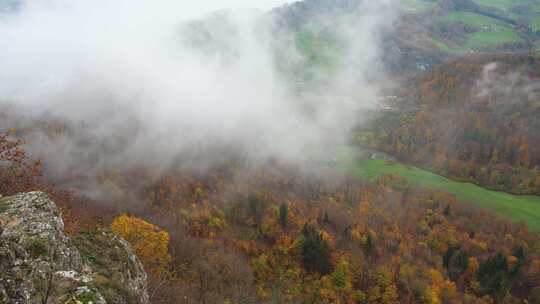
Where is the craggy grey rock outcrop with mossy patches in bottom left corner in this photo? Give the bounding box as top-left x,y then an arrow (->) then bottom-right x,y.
0,192 -> 149,304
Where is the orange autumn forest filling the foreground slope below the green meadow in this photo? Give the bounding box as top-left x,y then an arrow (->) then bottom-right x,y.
0,131 -> 540,303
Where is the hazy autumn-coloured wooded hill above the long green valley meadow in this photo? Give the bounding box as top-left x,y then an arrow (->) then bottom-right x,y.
358,55 -> 540,194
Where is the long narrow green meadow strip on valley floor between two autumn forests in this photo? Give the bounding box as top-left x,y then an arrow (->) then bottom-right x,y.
339,149 -> 540,231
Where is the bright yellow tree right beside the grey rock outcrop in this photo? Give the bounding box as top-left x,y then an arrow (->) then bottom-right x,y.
111,215 -> 171,273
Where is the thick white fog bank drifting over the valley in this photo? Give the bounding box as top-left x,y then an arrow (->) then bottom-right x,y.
0,0 -> 390,196
